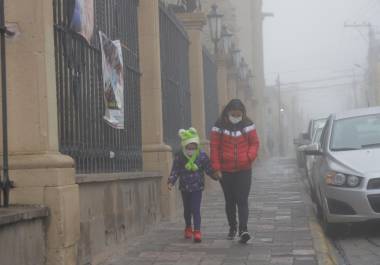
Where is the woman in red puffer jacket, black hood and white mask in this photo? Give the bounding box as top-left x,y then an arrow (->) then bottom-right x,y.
211,99 -> 259,243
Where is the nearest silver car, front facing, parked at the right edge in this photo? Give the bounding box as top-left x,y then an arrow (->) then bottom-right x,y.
305,107 -> 380,235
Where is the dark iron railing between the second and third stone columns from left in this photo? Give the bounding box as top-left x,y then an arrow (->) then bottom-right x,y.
160,3 -> 191,150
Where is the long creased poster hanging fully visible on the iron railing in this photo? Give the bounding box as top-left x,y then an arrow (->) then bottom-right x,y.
99,31 -> 124,129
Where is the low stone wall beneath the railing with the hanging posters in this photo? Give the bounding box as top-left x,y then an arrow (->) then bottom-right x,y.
77,173 -> 161,265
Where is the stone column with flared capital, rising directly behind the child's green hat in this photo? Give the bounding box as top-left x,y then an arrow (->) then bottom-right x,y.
177,12 -> 209,149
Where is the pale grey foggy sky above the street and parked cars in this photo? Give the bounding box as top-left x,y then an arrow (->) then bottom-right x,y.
232,0 -> 380,135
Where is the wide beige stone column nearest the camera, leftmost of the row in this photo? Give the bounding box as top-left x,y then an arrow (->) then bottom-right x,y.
5,0 -> 80,265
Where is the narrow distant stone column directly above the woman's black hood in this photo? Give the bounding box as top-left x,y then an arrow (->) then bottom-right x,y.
216,54 -> 228,112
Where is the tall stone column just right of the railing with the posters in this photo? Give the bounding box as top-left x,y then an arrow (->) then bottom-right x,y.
139,0 -> 178,220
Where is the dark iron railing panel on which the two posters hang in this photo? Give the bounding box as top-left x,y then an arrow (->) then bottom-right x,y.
53,0 -> 142,173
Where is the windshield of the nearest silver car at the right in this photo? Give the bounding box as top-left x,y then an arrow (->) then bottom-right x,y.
330,114 -> 380,151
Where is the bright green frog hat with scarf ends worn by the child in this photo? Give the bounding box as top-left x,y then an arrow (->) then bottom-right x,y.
178,127 -> 200,171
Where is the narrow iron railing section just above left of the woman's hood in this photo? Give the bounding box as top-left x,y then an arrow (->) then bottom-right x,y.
203,48 -> 219,137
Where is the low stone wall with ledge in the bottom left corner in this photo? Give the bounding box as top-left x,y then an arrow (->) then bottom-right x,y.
0,207 -> 48,265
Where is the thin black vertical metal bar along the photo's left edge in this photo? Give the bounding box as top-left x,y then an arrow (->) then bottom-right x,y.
0,0 -> 12,207
